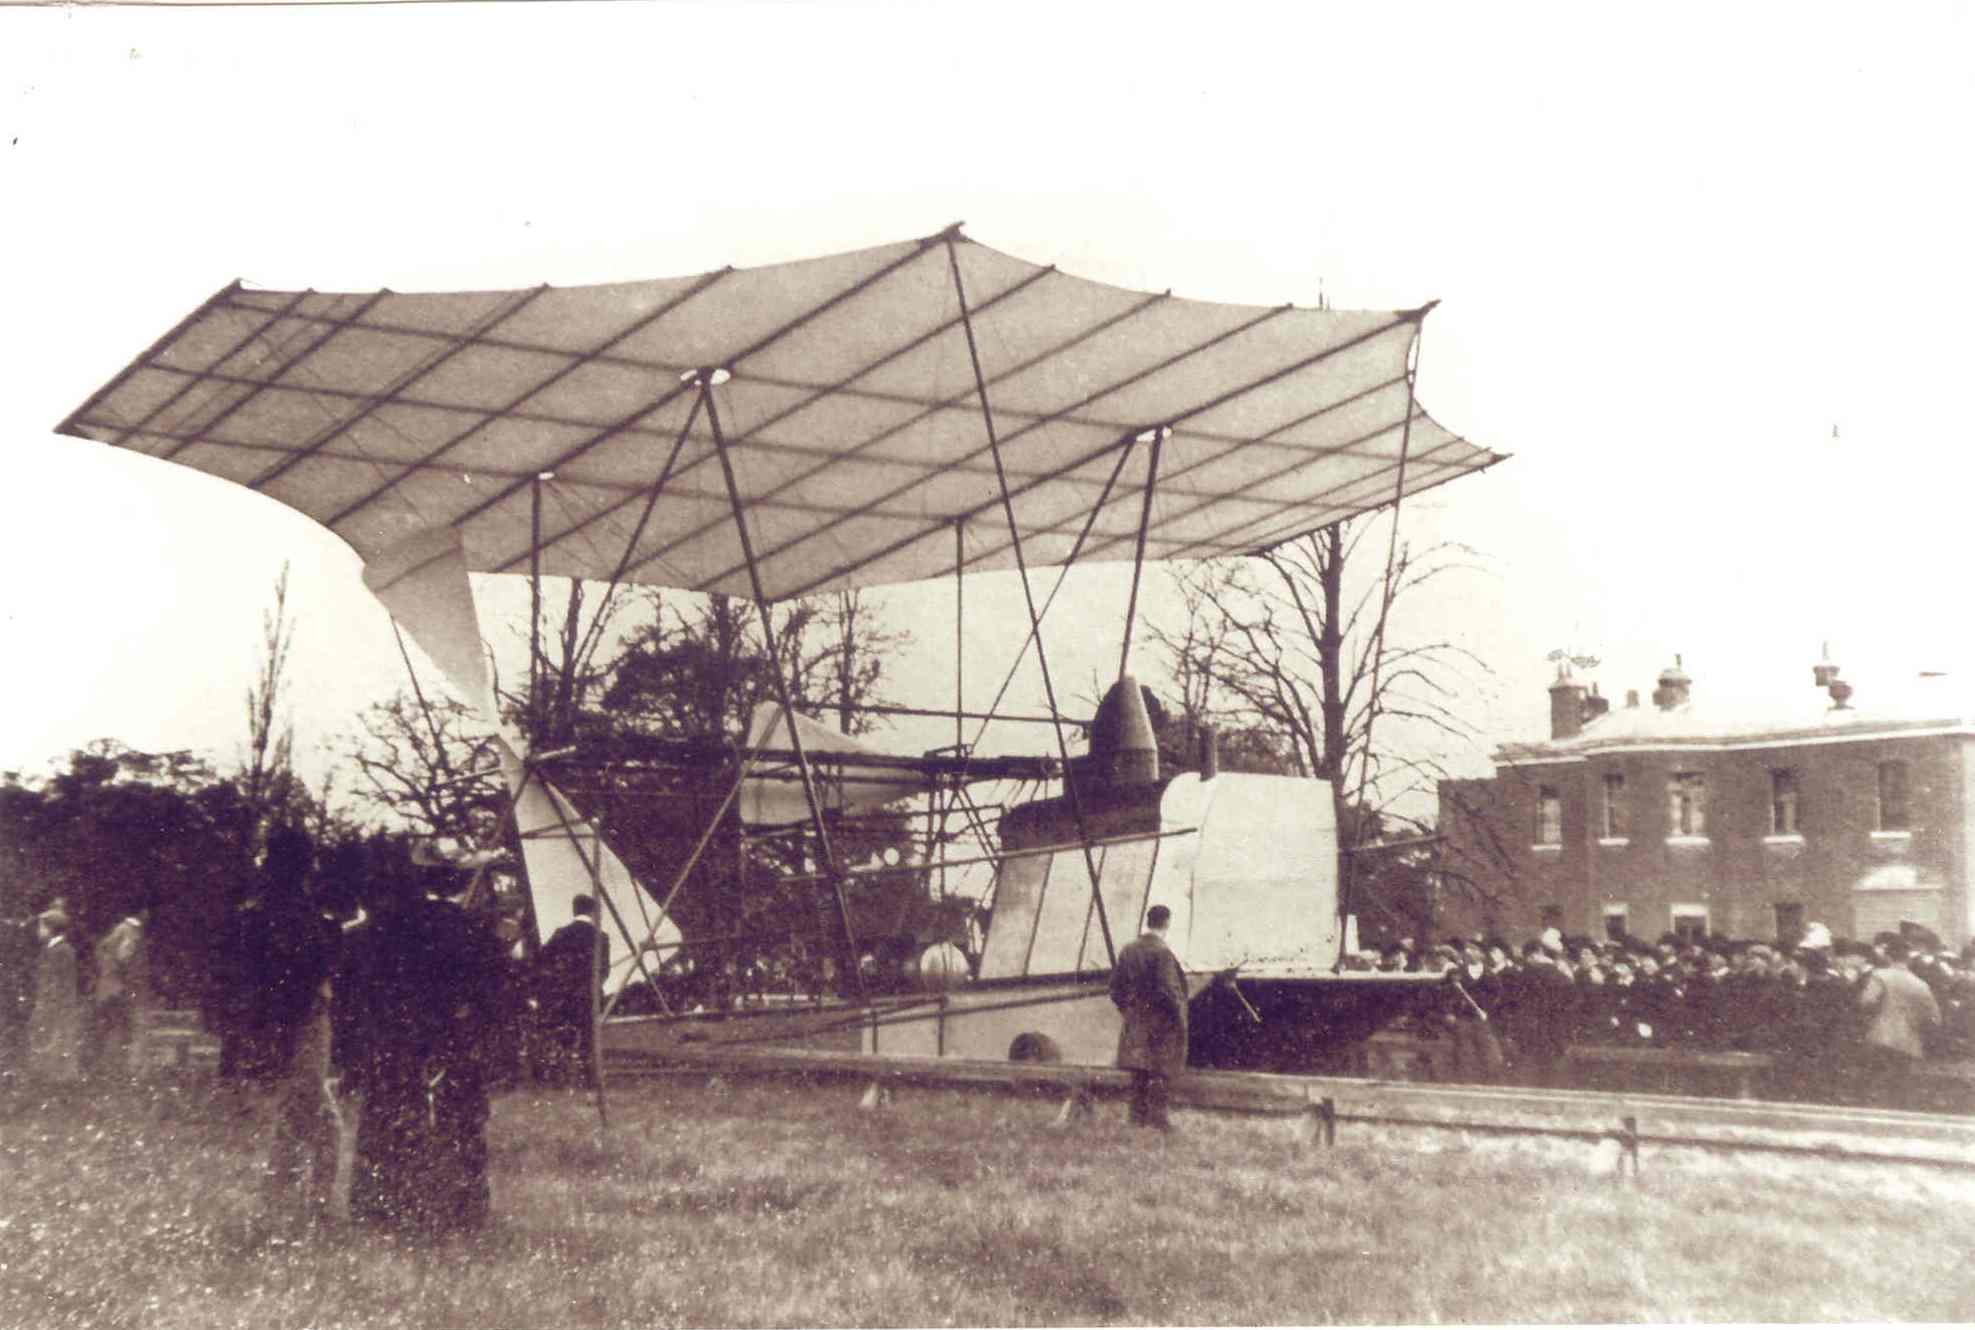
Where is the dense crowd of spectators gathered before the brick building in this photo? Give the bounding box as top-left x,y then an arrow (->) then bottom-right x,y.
1353,923 -> 1975,1103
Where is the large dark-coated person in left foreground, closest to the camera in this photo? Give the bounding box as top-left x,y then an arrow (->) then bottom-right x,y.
334,868 -> 504,1233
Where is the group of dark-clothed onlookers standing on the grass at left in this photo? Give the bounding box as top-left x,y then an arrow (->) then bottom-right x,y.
0,828 -> 604,1239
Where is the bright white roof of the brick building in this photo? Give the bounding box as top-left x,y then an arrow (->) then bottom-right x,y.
1495,676 -> 1975,765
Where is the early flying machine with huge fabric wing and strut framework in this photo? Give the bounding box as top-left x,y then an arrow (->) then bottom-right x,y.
61,227 -> 1499,1065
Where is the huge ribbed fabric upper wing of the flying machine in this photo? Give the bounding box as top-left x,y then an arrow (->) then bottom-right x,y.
61,231 -> 1499,599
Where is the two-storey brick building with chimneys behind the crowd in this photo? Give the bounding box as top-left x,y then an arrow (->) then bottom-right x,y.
1436,662 -> 1975,947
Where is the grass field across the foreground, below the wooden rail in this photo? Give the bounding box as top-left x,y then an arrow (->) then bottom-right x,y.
0,1077 -> 1975,1330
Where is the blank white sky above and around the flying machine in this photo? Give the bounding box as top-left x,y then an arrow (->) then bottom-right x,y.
0,4 -> 1975,818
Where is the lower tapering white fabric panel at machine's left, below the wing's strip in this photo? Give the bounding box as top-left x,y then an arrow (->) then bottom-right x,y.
494,737 -> 681,953
